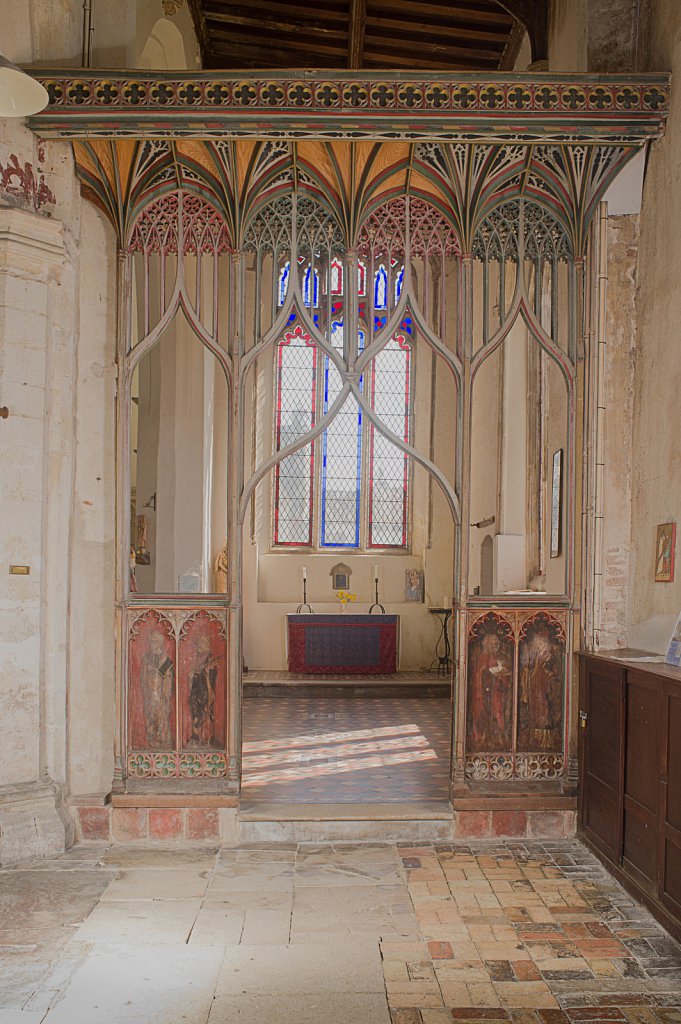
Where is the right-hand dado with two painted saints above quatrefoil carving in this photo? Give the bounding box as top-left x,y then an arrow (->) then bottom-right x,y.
465,608 -> 567,781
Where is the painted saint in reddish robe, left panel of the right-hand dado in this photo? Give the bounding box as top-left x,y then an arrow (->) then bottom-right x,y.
467,632 -> 513,752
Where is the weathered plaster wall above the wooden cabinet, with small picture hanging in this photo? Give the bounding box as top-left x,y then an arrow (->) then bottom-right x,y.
628,0 -> 681,651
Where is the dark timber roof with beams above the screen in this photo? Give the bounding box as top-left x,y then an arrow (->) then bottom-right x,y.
190,0 -> 528,72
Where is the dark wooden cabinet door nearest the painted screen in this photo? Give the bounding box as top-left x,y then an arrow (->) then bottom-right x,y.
580,658 -> 625,864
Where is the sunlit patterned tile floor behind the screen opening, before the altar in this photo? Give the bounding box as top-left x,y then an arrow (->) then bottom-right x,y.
242,696 -> 450,803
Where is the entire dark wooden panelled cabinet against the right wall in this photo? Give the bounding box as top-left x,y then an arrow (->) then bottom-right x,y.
580,651 -> 681,936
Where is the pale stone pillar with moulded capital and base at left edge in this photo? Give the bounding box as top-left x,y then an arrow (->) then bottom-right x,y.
0,208 -> 71,864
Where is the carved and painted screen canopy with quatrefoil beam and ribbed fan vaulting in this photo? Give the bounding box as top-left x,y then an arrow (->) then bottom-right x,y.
30,71 -> 669,255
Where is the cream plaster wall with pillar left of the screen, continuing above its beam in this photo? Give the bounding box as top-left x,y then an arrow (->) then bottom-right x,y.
0,0 -> 197,863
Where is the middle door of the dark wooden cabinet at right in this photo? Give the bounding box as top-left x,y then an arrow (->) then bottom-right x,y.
623,669 -> 663,895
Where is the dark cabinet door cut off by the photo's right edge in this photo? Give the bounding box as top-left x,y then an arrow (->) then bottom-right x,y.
659,683 -> 681,922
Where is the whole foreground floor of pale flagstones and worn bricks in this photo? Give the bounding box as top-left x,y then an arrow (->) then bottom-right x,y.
0,841 -> 681,1024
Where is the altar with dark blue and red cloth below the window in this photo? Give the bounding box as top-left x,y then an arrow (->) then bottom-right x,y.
287,614 -> 399,676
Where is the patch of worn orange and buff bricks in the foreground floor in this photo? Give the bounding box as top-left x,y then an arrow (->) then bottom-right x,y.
381,841 -> 681,1024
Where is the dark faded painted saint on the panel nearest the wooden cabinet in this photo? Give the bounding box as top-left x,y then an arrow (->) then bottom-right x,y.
518,624 -> 563,751
